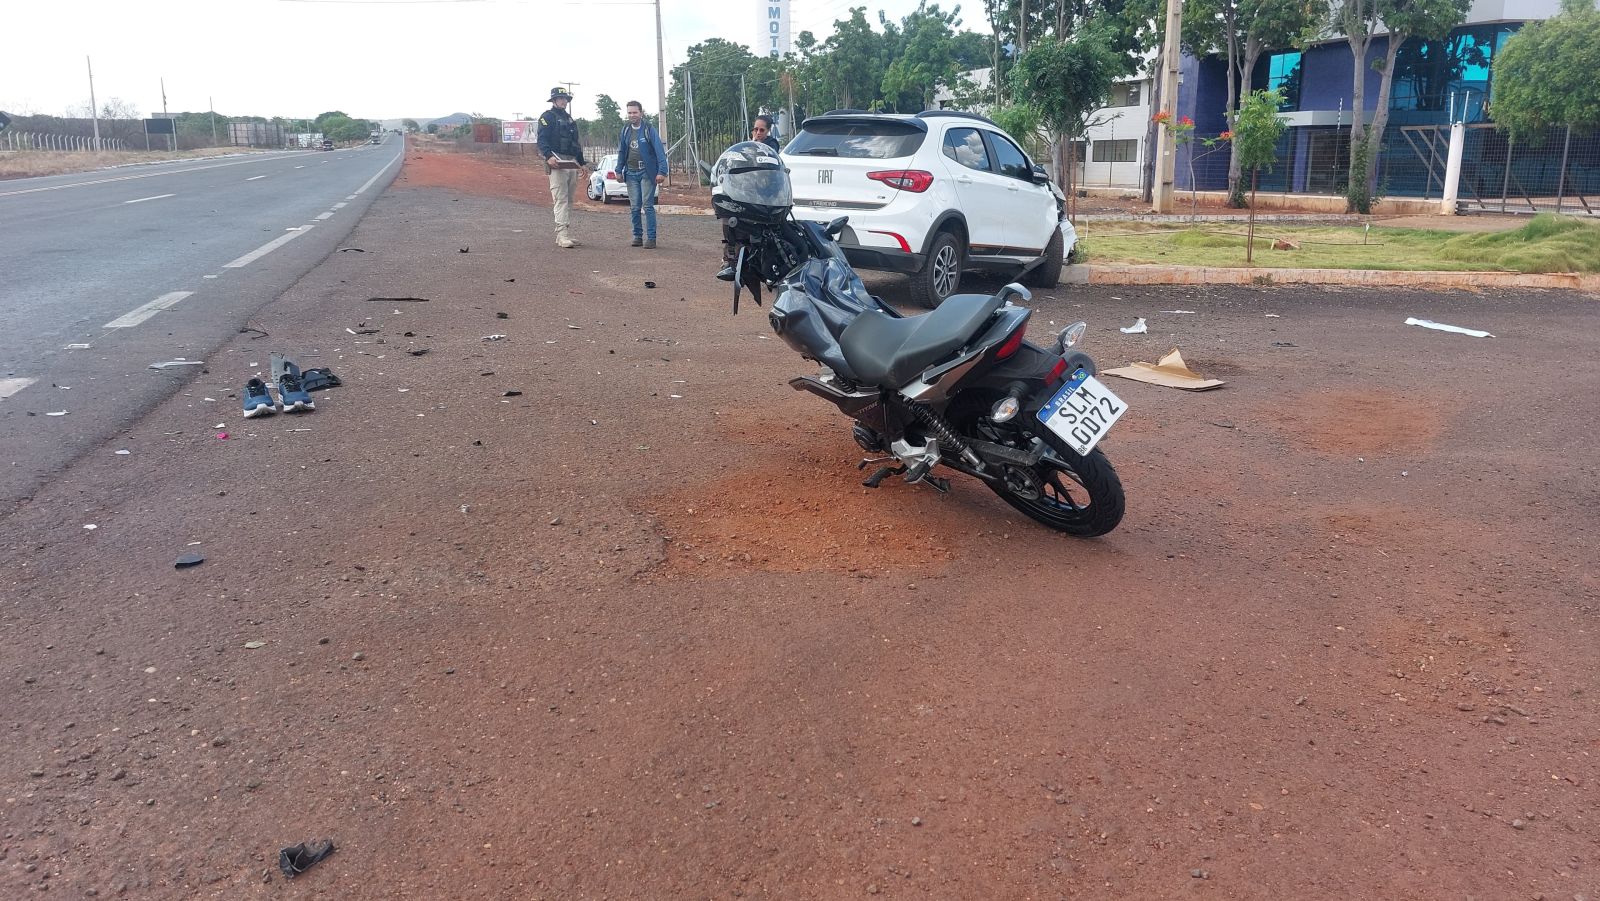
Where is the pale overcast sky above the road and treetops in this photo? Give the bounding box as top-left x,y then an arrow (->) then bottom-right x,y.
0,0 -> 947,120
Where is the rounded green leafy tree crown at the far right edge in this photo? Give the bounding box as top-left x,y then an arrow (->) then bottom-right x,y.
1490,0 -> 1600,139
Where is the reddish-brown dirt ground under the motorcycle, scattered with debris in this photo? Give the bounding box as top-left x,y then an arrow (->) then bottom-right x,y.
0,144 -> 1600,901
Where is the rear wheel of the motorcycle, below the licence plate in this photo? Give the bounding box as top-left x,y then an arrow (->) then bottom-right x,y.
987,427 -> 1126,538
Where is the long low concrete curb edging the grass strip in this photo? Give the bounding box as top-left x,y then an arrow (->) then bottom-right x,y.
1061,262 -> 1600,293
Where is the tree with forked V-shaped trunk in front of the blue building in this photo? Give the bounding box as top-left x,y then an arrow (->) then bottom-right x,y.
1330,0 -> 1472,213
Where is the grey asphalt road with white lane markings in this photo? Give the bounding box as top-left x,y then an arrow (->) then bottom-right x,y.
0,138 -> 405,503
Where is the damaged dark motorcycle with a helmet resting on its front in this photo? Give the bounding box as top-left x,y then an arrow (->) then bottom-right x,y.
712,142 -> 1128,538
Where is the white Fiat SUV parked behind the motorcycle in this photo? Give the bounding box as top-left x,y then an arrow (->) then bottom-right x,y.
782,110 -> 1077,307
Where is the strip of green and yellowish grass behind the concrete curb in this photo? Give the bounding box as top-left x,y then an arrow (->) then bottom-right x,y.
1080,214 -> 1600,272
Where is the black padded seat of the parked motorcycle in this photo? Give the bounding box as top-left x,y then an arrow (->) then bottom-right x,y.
838,294 -> 1005,387
